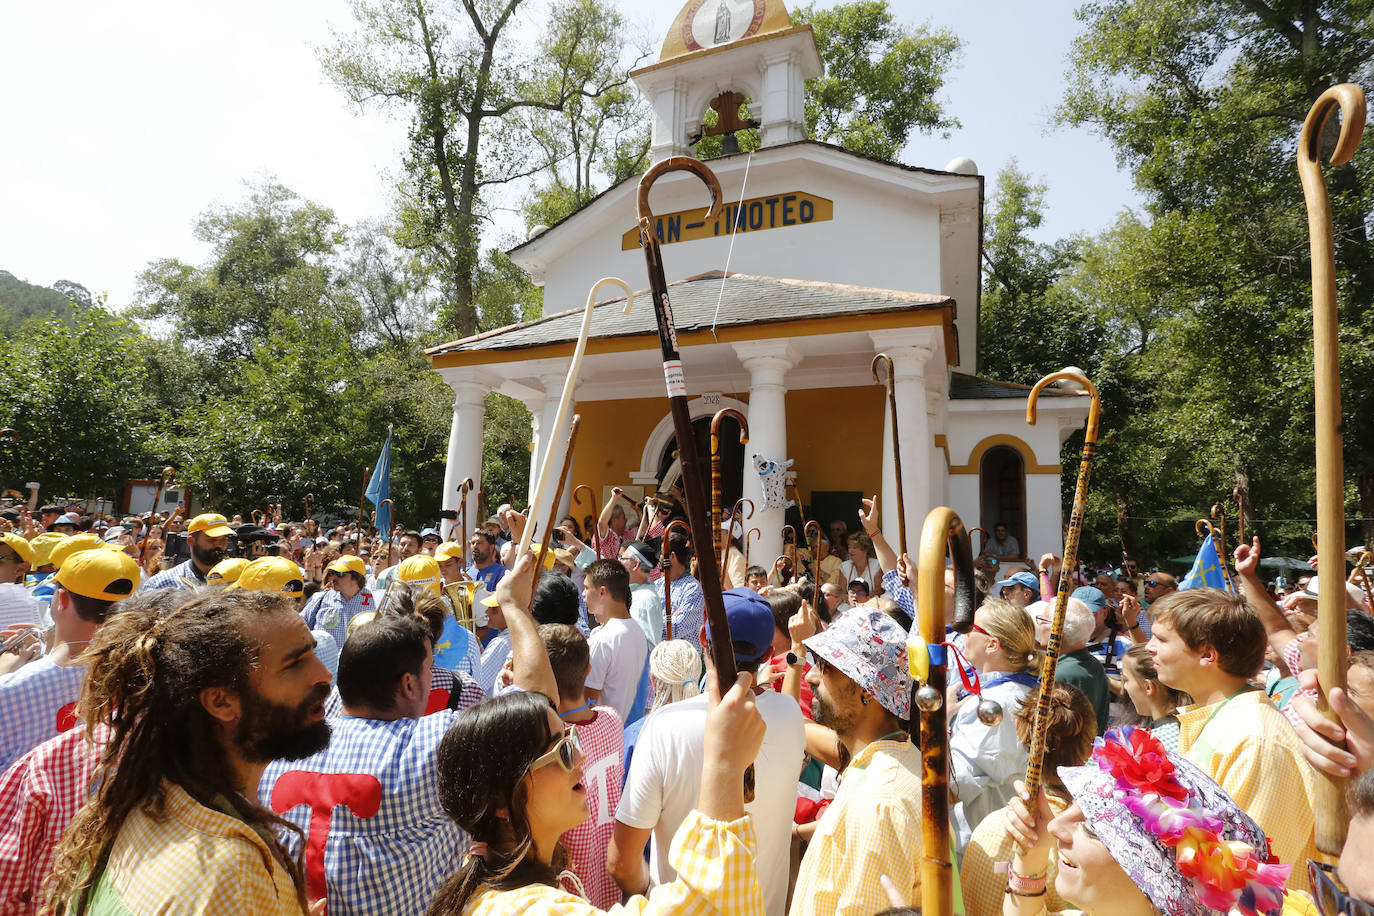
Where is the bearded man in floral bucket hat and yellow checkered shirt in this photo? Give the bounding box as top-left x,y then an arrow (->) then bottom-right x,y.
791,608 -> 917,916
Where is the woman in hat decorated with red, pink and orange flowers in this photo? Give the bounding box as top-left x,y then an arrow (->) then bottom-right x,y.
1002,725 -> 1308,916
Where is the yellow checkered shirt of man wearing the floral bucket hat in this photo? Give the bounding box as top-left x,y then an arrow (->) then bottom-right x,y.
789,740 -> 921,916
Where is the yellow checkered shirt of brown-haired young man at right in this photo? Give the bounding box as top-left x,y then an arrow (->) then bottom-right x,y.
1179,691 -> 1318,891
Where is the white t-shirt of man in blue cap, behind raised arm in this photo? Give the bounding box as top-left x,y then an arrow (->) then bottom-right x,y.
616,691 -> 807,916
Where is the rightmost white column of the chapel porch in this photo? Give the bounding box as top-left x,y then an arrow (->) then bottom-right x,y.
872,334 -> 934,560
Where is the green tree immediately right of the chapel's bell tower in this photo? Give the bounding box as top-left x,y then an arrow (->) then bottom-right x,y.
791,0 -> 960,159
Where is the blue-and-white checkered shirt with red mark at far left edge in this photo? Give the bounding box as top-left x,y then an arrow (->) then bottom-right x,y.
0,658 -> 87,773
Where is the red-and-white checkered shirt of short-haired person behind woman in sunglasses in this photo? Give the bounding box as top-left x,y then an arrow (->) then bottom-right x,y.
563,706 -> 625,909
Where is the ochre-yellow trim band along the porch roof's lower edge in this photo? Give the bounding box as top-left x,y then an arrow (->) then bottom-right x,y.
430,304 -> 959,369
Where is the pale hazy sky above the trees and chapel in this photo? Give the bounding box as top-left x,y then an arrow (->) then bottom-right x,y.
0,0 -> 1136,308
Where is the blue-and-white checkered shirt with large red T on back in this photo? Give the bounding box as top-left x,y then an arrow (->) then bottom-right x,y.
258,710 -> 467,916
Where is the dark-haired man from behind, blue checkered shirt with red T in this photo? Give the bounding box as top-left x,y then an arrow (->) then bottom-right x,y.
258,612 -> 466,916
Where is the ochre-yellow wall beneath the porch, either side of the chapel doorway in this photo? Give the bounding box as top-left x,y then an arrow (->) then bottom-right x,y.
569,385 -> 886,513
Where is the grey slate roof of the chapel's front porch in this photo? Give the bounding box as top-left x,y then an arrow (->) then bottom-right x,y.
425,271 -> 955,357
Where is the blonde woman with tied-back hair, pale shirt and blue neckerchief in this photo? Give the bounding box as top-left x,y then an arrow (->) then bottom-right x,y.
949,597 -> 1040,856
